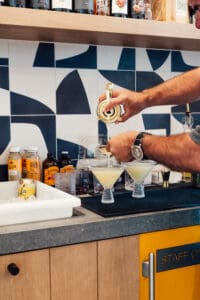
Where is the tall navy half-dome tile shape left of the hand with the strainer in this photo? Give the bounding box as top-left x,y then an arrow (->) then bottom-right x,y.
56,71 -> 91,115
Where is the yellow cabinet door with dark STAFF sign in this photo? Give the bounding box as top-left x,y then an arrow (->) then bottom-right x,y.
140,225 -> 200,300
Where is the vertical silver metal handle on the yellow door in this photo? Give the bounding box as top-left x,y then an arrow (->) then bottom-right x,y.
142,252 -> 155,300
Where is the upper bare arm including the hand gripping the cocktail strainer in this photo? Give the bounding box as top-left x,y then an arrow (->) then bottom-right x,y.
99,68 -> 200,122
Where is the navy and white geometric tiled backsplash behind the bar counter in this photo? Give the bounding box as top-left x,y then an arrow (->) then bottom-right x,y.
0,40 -> 200,180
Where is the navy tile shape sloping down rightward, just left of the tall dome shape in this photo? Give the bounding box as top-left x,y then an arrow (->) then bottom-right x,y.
10,92 -> 54,115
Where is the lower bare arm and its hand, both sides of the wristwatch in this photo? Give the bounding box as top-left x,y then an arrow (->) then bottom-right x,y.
107,131 -> 200,172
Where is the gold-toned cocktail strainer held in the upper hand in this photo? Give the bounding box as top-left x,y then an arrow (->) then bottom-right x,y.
97,83 -> 121,123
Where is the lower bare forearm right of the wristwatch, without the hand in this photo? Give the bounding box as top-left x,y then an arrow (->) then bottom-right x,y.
142,133 -> 200,172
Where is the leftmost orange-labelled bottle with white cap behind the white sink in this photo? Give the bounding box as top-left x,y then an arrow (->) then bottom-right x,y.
8,147 -> 22,181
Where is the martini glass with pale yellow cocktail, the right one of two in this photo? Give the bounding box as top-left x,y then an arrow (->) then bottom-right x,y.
124,160 -> 156,198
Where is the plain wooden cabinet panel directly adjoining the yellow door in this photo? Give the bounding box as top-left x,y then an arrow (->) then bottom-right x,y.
98,236 -> 139,300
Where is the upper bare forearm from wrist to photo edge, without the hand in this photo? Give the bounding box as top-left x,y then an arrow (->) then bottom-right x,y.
142,68 -> 200,107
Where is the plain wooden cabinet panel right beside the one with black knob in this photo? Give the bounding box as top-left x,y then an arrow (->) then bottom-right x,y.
50,242 -> 97,300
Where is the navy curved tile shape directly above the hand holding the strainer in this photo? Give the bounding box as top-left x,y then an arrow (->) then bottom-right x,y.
99,70 -> 135,90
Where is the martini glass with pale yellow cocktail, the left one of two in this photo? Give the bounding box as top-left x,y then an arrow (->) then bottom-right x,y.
89,155 -> 124,204
